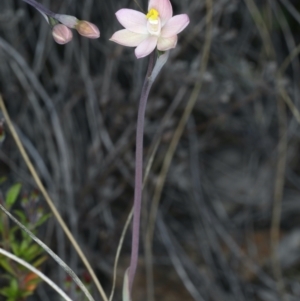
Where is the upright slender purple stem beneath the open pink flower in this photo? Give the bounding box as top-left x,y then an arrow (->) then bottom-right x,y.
129,52 -> 154,291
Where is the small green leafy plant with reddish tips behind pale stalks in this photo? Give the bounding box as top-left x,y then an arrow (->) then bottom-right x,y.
0,179 -> 49,301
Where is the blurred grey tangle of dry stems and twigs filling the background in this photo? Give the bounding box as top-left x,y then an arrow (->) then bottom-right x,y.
0,0 -> 300,301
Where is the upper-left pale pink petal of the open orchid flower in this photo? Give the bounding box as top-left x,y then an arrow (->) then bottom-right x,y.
116,8 -> 147,34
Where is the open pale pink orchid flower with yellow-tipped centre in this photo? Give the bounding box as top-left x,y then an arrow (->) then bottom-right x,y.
110,0 -> 190,58
